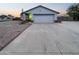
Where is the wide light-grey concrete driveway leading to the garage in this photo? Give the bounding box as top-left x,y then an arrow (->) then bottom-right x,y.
0,22 -> 79,55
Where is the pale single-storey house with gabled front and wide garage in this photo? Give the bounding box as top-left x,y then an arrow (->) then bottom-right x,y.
21,5 -> 59,23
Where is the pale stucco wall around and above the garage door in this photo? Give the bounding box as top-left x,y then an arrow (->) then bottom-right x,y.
23,7 -> 57,20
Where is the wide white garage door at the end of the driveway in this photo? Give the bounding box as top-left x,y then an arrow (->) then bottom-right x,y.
33,14 -> 54,23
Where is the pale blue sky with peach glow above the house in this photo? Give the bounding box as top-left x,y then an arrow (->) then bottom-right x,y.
0,3 -> 72,17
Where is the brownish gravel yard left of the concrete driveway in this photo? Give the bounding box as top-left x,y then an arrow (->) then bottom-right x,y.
0,21 -> 30,49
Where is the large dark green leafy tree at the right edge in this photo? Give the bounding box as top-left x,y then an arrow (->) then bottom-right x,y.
67,4 -> 79,21
